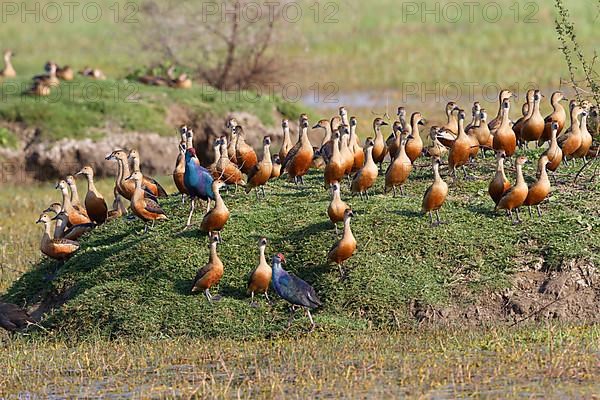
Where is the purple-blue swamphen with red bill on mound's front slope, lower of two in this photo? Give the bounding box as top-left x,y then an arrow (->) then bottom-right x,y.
271,253 -> 323,331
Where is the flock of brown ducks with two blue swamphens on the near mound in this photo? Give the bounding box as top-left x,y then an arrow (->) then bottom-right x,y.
4,86 -> 598,328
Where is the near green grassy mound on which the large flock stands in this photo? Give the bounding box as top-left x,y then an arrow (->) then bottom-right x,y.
4,152 -> 600,338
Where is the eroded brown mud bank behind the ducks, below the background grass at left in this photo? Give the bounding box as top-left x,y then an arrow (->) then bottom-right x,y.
0,112 -> 312,183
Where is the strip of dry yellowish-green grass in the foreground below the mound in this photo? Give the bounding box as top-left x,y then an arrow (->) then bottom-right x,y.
0,325 -> 600,399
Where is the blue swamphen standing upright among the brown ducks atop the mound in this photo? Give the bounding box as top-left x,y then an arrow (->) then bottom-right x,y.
183,147 -> 216,228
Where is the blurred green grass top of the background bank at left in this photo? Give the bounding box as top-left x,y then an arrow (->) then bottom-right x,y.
0,77 -> 300,141
